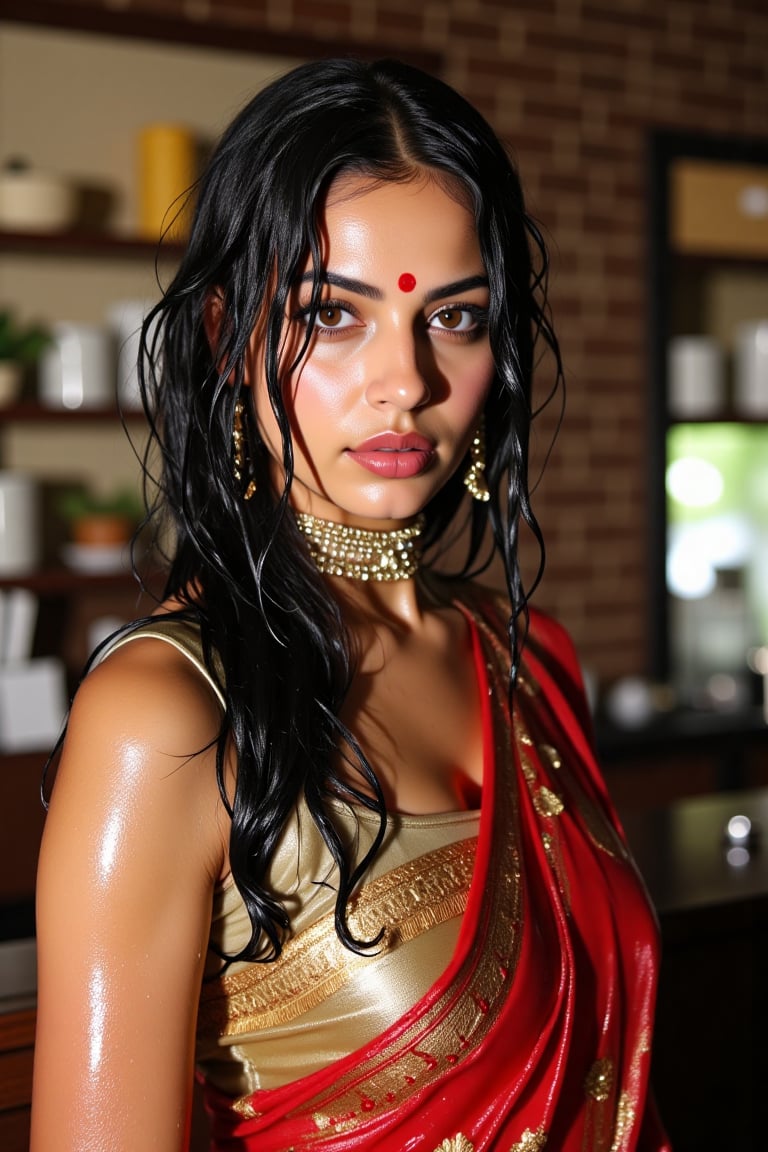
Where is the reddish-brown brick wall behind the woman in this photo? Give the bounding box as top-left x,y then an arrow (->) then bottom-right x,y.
12,0 -> 768,680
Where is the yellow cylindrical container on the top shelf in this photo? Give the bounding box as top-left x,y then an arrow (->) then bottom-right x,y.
138,124 -> 197,241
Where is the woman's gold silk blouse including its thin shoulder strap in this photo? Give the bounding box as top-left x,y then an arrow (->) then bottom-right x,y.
101,617 -> 480,1097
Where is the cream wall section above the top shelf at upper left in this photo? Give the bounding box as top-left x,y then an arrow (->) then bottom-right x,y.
0,24 -> 290,233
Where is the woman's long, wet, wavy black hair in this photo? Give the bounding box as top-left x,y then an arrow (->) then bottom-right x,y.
139,60 -> 561,960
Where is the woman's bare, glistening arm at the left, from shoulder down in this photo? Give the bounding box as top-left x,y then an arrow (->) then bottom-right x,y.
31,639 -> 228,1152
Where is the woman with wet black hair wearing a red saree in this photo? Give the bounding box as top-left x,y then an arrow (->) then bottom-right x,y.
32,61 -> 667,1152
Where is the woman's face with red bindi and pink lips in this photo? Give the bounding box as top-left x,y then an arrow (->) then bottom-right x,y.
251,170 -> 494,528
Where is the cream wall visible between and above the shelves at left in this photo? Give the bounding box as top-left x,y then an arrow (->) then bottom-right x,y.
0,22 -> 296,491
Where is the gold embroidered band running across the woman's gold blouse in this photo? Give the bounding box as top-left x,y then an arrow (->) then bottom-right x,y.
198,836 -> 477,1037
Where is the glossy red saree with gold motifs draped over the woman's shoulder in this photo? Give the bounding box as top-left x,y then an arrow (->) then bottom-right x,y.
201,598 -> 669,1152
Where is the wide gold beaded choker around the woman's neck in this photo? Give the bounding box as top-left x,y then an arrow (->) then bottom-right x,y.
296,511 -> 424,581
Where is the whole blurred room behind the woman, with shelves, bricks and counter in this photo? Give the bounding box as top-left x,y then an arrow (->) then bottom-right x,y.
0,0 -> 768,1150
